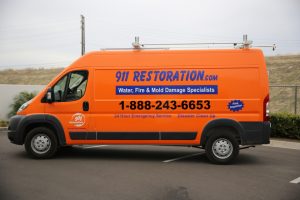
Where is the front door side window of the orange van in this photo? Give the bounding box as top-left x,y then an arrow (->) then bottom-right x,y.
53,71 -> 88,102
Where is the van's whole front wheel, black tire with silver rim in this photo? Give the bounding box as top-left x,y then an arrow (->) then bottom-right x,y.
25,127 -> 58,159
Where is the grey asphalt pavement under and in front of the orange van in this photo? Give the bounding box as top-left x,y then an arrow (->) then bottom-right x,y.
0,133 -> 300,200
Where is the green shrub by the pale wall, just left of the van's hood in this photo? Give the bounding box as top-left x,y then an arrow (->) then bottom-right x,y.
7,91 -> 36,118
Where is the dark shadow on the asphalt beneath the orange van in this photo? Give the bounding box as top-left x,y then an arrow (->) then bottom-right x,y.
51,147 -> 261,165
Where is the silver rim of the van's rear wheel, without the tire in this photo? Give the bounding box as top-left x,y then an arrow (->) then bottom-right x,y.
212,138 -> 233,159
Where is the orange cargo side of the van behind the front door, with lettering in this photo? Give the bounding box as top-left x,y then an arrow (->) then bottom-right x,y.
64,51 -> 266,145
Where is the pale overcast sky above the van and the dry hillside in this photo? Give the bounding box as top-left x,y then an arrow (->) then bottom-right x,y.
0,0 -> 300,70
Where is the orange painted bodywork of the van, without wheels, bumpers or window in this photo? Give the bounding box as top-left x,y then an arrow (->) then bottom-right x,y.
18,49 -> 269,145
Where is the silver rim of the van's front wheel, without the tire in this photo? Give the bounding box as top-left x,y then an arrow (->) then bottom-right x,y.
31,133 -> 51,154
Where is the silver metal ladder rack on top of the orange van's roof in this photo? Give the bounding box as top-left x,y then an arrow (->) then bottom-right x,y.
132,34 -> 276,51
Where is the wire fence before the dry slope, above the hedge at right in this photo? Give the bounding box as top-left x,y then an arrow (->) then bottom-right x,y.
270,85 -> 300,114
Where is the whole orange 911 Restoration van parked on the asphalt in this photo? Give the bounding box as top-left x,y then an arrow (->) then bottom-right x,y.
8,49 -> 270,164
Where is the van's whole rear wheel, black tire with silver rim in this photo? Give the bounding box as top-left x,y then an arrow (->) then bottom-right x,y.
205,128 -> 239,164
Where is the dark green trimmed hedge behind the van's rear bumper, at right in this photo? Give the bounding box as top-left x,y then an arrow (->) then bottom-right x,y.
270,113 -> 300,139
